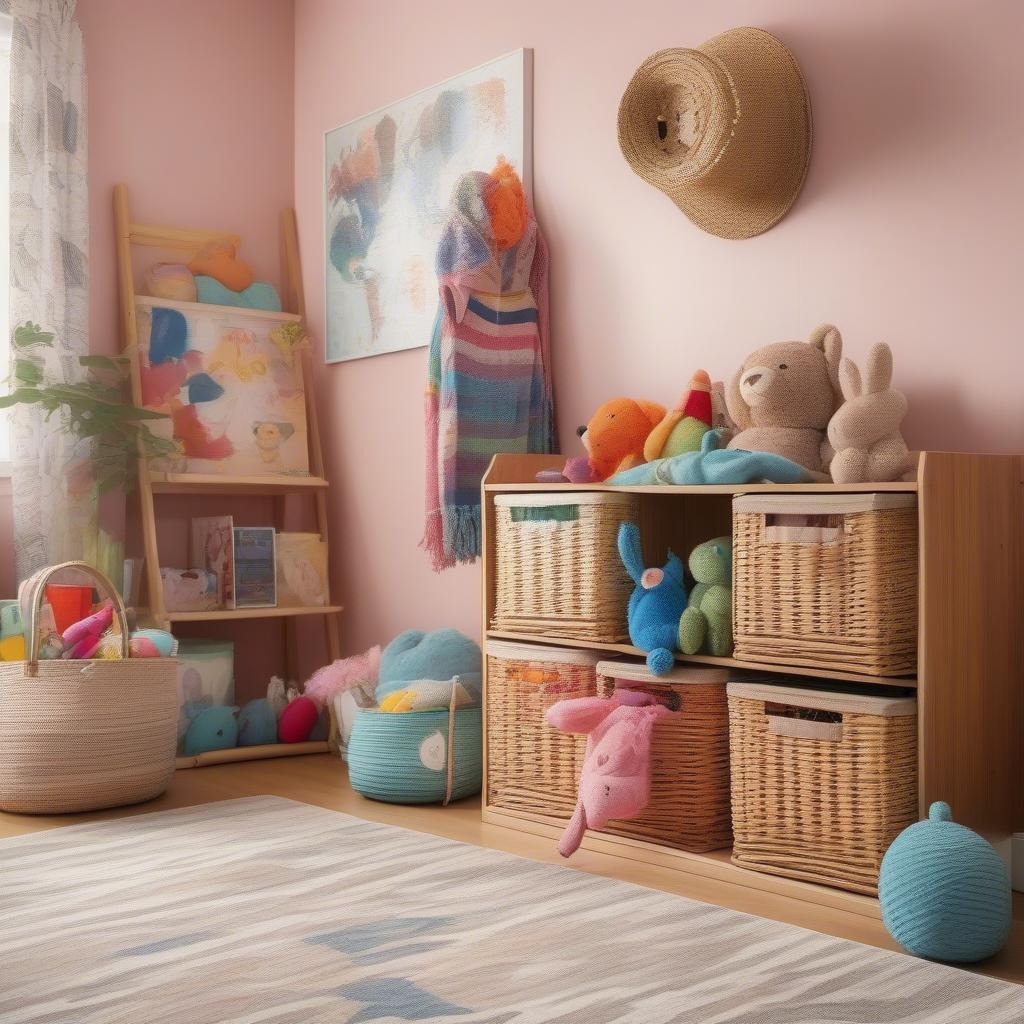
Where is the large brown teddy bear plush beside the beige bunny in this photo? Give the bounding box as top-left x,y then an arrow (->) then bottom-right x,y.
726,324 -> 843,479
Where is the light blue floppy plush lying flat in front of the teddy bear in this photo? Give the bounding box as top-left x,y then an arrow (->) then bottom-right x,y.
607,430 -> 811,485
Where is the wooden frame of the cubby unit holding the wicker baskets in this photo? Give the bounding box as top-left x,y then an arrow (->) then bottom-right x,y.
482,452 -> 1024,918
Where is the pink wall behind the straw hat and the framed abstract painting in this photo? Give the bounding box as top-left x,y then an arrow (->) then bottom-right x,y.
295,0 -> 1024,648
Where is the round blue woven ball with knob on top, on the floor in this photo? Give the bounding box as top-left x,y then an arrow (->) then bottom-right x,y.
879,801 -> 1012,964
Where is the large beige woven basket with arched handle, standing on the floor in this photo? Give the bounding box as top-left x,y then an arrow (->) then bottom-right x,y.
0,562 -> 178,814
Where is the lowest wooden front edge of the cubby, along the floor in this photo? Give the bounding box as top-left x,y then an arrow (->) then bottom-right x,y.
480,805 -> 881,921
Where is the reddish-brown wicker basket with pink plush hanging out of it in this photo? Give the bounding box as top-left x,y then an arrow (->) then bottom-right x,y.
597,662 -> 732,853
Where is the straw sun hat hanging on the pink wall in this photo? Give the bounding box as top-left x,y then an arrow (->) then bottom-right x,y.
618,29 -> 811,239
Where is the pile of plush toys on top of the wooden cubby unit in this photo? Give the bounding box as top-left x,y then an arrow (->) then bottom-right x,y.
539,324 -> 910,485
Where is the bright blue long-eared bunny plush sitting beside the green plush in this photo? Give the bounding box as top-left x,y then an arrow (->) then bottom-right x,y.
618,522 -> 686,676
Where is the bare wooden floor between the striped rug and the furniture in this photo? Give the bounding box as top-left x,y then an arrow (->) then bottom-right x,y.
0,755 -> 1024,983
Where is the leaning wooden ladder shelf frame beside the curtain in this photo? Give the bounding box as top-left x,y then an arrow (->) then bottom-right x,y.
114,184 -> 342,767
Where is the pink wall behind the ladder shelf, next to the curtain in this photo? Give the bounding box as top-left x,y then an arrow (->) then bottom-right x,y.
74,0 -> 294,696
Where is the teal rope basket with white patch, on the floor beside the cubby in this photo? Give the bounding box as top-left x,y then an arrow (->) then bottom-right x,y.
348,708 -> 483,804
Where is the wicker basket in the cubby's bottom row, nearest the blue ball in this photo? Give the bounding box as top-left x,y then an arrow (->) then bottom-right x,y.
728,683 -> 918,896
